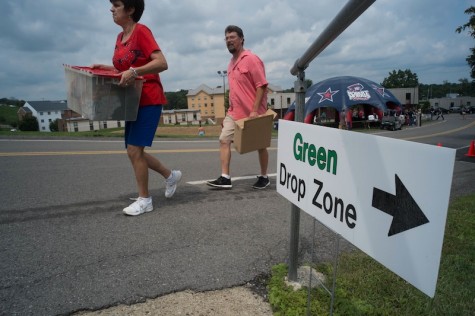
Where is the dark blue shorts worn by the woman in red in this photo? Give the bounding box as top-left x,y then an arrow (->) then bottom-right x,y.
124,105 -> 162,148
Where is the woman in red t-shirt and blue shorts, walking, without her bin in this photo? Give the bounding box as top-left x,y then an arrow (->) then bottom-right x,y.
92,0 -> 181,215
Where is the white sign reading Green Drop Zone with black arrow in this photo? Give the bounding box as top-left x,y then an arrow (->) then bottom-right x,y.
276,120 -> 455,297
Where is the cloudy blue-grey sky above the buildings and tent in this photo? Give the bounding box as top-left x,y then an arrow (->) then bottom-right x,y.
0,0 -> 475,101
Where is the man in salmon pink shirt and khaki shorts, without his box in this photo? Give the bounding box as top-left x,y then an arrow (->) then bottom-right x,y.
207,25 -> 269,189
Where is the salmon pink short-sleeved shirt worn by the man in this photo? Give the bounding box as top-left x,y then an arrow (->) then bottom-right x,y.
227,50 -> 268,120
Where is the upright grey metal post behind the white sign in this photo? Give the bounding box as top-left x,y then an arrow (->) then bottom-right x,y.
288,71 -> 307,282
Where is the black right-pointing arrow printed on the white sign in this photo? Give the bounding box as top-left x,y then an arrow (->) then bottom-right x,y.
372,174 -> 429,236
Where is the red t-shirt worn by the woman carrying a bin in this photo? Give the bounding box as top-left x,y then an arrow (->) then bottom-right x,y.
112,23 -> 167,107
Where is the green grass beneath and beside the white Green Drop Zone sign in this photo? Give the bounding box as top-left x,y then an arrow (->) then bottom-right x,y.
268,194 -> 475,316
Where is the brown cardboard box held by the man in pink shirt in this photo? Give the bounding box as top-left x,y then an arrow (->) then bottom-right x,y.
234,109 -> 277,154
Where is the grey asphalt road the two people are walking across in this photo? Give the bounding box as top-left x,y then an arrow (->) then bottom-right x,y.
0,114 -> 475,315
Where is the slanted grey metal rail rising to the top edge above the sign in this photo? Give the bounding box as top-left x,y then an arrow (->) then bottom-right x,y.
290,0 -> 376,76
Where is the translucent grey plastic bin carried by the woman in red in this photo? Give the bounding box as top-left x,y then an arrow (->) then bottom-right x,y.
64,65 -> 143,121
